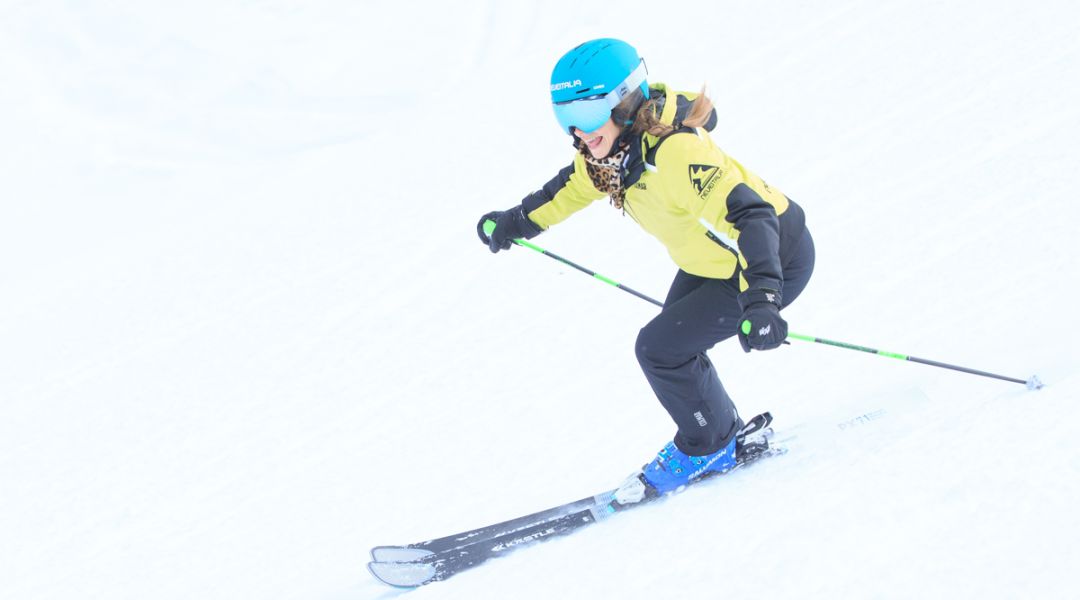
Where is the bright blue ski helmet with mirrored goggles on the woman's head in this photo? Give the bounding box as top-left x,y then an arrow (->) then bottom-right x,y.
551,38 -> 649,135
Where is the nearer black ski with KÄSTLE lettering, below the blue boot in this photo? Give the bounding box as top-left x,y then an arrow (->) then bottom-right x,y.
367,413 -> 786,587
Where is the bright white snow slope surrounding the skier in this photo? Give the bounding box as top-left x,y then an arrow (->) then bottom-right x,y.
0,0 -> 1080,600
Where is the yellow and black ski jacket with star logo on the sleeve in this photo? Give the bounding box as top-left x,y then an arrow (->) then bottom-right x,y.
522,84 -> 806,290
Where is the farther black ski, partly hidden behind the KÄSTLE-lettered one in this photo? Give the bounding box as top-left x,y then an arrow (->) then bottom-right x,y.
372,412 -> 772,562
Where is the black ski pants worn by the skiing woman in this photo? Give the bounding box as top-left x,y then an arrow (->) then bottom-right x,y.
636,230 -> 814,456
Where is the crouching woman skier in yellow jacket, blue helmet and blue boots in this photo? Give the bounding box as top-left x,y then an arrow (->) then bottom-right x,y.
476,39 -> 814,493
